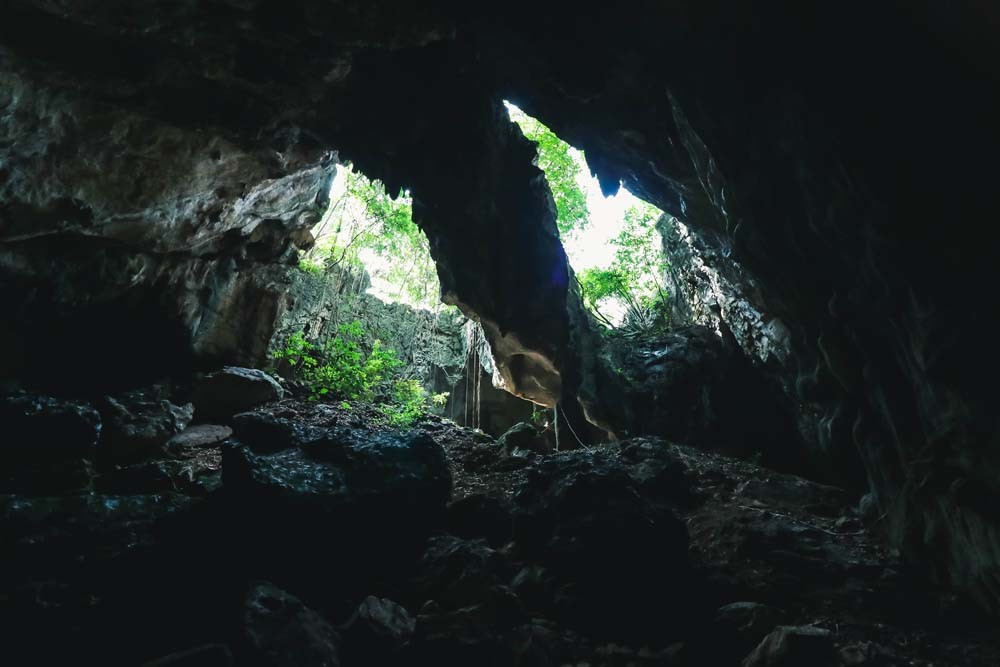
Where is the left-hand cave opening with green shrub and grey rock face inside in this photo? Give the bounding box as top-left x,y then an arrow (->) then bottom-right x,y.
272,164 -> 533,435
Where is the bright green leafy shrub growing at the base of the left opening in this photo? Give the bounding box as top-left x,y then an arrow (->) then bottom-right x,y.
272,320 -> 448,428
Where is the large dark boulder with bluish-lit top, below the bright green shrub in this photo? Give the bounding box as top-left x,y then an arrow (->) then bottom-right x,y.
222,428 -> 451,596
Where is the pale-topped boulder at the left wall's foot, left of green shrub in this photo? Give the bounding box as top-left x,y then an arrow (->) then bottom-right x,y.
193,366 -> 285,421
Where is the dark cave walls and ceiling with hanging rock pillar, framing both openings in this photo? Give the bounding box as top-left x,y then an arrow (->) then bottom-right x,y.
0,0 -> 1000,609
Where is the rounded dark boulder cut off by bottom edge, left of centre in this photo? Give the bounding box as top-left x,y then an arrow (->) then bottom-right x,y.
243,582 -> 340,667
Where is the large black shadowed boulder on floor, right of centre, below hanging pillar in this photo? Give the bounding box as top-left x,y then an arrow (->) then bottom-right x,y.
514,449 -> 690,640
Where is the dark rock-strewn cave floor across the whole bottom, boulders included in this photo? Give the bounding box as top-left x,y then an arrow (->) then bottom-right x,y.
0,380 -> 1000,667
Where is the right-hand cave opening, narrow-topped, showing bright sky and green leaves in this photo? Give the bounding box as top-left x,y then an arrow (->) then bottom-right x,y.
504,101 -> 669,329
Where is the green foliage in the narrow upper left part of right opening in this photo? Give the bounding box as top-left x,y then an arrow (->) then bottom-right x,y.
507,106 -> 590,235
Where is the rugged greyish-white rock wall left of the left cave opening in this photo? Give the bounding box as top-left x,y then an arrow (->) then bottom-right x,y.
0,62 -> 332,392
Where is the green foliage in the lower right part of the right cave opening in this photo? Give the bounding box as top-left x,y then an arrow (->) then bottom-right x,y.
577,204 -> 668,328
